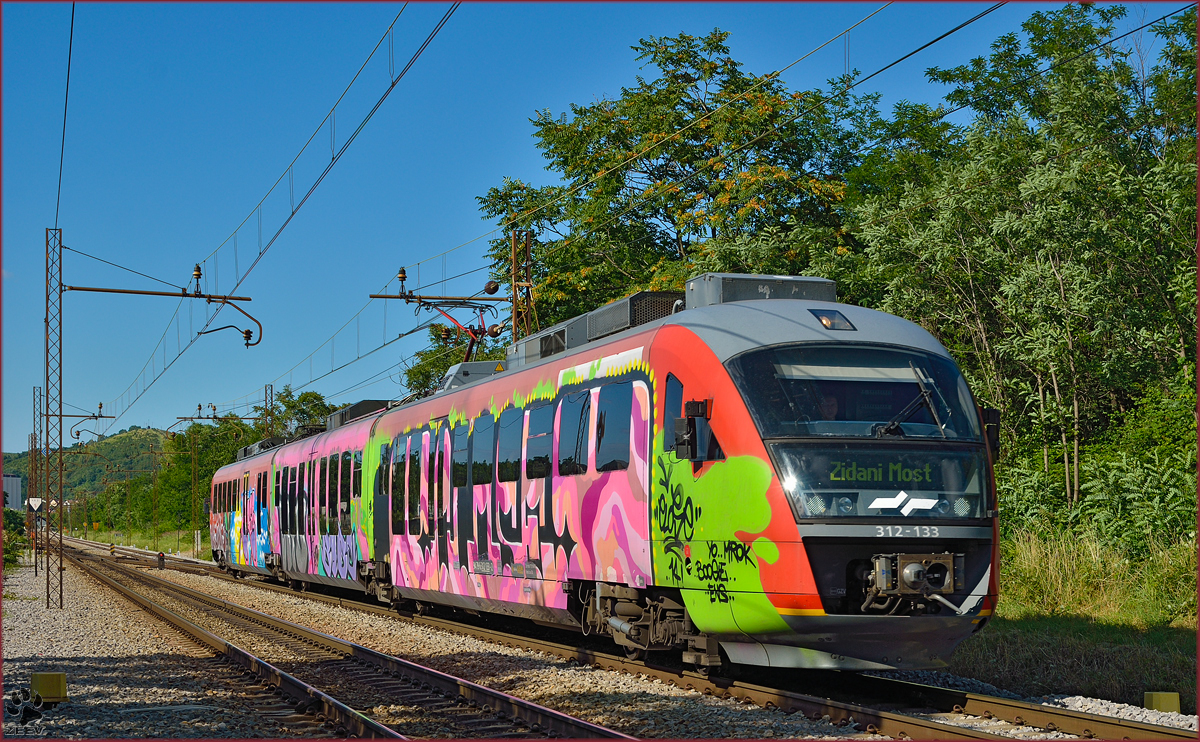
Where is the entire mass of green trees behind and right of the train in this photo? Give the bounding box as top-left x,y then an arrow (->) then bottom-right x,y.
480,5 -> 1196,538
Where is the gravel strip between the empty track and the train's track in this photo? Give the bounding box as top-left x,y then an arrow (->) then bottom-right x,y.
154,570 -> 882,738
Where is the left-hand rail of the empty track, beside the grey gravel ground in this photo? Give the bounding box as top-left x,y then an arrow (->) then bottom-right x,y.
64,555 -> 408,740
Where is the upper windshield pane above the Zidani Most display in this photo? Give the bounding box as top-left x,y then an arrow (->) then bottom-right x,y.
726,343 -> 982,443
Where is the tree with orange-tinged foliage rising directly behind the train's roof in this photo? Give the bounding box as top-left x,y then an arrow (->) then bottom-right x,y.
479,30 -> 878,325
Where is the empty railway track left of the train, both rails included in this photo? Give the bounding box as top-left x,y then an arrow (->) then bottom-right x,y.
64,540 -> 631,738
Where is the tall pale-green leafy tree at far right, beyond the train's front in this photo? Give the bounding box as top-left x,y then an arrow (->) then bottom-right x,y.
852,6 -> 1196,503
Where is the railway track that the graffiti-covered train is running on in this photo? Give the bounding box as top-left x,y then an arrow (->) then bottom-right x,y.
70,537 -> 1196,740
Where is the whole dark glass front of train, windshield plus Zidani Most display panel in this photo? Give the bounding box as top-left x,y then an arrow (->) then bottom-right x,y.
728,345 -> 989,519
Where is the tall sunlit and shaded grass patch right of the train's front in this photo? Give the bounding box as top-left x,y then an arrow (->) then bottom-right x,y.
949,529 -> 1196,713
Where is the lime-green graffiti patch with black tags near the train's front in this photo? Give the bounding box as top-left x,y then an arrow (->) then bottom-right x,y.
652,446 -> 787,633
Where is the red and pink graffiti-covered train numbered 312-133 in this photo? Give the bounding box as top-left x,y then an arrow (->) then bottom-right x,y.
210,274 -> 998,670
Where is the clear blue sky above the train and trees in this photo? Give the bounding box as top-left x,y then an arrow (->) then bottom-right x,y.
2,2 -> 1182,451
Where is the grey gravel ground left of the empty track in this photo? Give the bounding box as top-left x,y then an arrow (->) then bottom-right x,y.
4,557 -> 312,738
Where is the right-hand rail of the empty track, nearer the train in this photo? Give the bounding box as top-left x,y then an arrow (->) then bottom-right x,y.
76,540 -> 637,740
